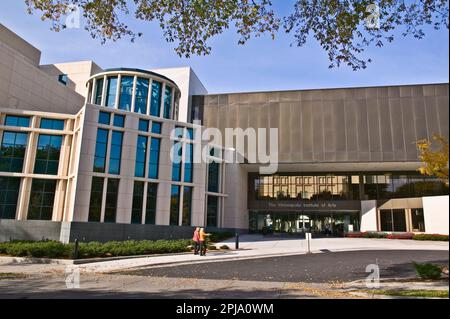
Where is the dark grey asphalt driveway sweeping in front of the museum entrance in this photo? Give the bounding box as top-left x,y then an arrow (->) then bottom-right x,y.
121,250 -> 449,283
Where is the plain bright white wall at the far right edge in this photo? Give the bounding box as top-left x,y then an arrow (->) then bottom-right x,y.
423,196 -> 449,235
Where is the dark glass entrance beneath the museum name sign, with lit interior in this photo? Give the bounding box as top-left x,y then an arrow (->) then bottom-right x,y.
249,211 -> 360,237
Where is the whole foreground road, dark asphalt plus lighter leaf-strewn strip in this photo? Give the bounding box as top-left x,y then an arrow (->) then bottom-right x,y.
0,250 -> 449,299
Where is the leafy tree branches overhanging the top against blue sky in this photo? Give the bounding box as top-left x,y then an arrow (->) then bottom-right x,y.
24,0 -> 449,70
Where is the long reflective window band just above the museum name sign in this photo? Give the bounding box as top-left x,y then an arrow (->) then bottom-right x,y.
253,173 -> 448,200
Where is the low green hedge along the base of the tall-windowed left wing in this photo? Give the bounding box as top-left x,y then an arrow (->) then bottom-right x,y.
0,239 -> 192,258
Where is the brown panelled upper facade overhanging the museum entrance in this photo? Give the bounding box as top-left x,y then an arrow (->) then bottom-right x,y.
203,84 -> 449,163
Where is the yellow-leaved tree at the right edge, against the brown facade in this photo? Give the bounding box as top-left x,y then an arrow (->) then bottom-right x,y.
417,134 -> 449,185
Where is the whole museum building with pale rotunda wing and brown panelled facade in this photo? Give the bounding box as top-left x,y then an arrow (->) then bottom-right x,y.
0,25 -> 449,242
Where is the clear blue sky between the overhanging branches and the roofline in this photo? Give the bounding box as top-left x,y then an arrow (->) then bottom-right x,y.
0,0 -> 449,93
